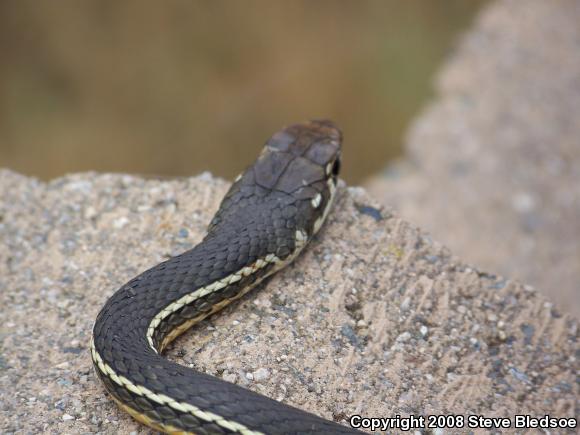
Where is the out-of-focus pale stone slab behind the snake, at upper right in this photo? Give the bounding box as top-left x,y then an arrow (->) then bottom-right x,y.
367,0 -> 580,316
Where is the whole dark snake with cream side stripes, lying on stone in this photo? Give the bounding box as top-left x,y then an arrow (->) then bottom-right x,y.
90,120 -> 361,435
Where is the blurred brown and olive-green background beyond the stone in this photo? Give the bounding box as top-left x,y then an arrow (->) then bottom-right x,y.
0,0 -> 485,183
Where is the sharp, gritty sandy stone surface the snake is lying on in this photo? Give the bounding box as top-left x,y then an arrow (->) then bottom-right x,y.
0,171 -> 580,434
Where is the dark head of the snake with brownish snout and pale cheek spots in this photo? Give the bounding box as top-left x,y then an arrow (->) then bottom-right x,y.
209,120 -> 342,239
